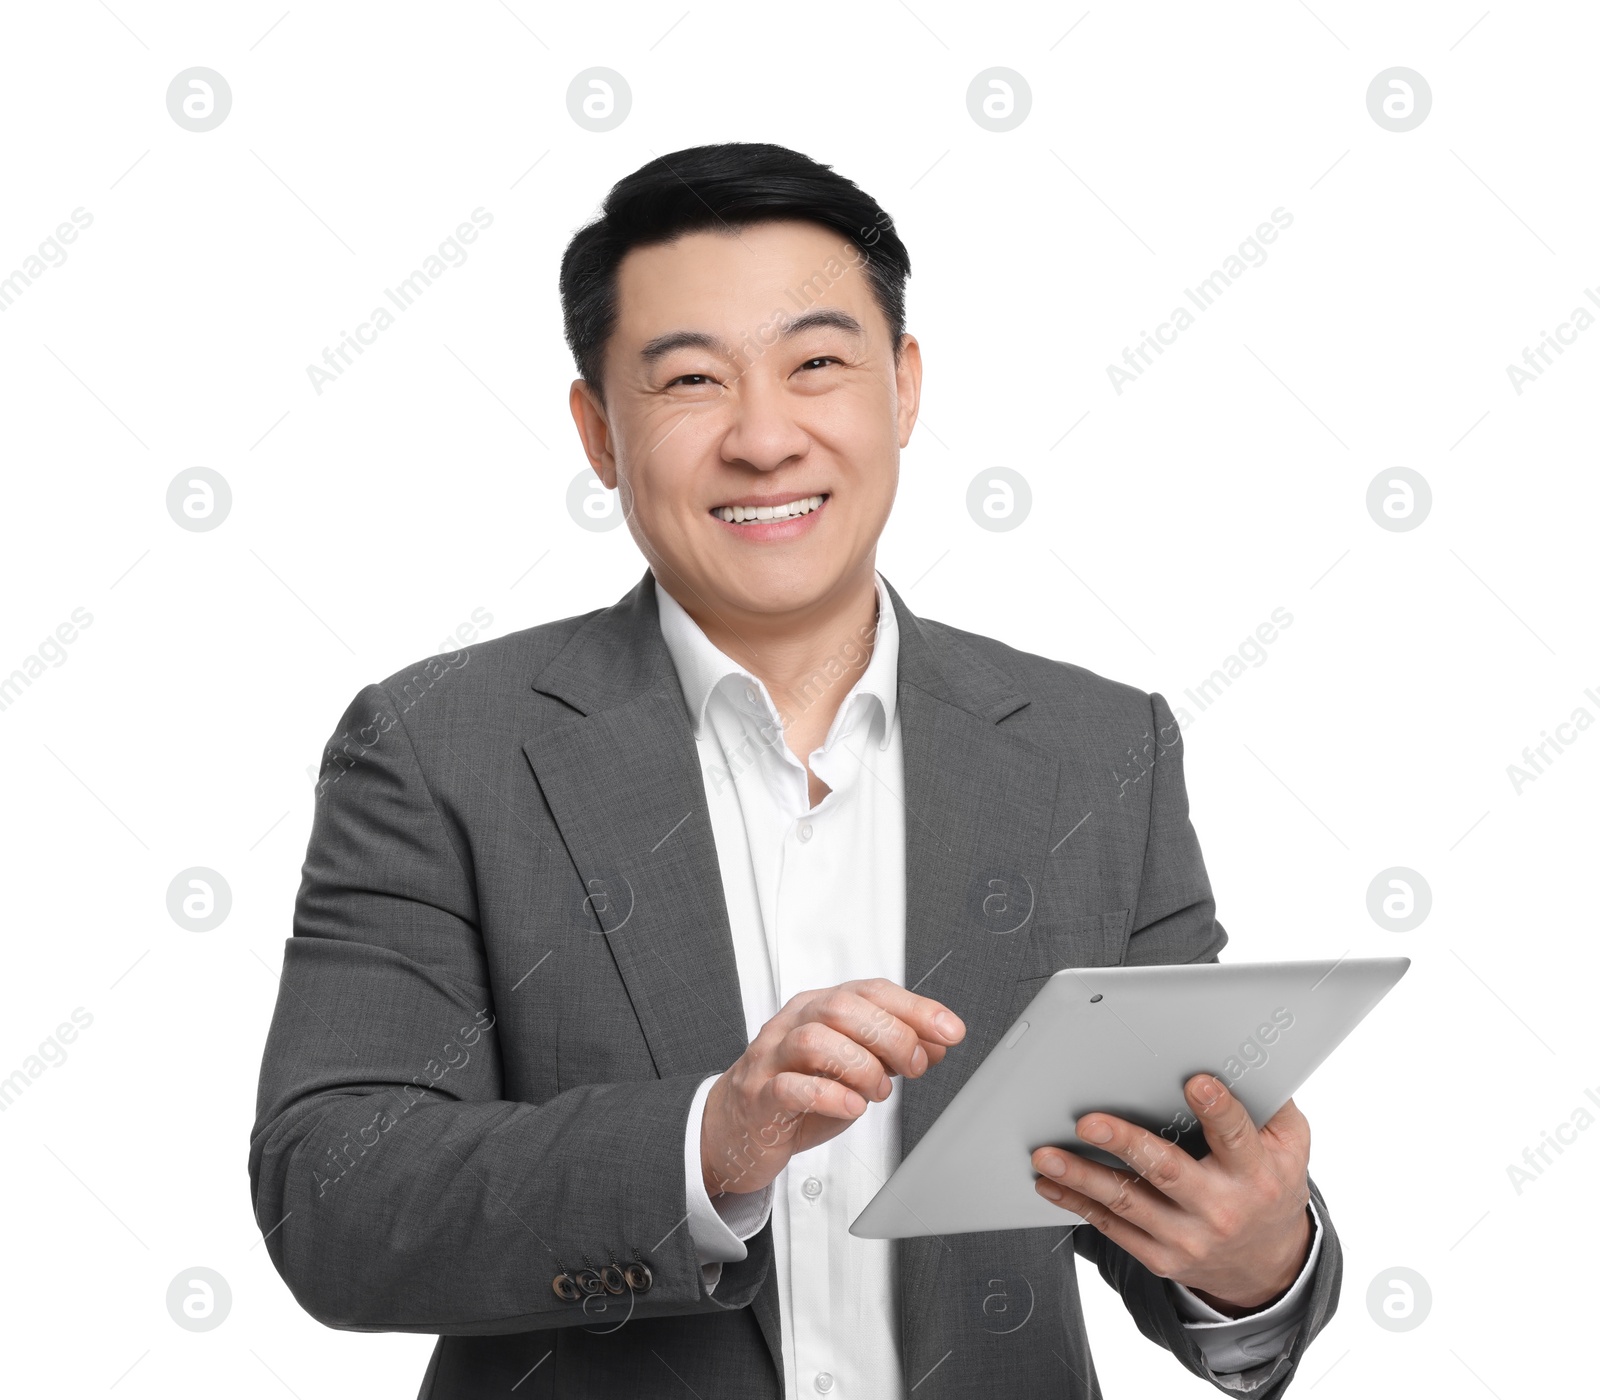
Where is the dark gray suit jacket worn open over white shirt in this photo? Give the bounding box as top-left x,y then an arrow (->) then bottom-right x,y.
250,574 -> 1339,1400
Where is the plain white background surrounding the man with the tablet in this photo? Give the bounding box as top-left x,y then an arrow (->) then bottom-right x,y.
0,0 -> 1600,1400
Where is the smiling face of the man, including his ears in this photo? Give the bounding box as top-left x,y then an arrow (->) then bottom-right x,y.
571,222 -> 922,619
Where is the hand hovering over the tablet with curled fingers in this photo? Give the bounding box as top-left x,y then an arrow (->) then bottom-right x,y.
701,978 -> 966,1195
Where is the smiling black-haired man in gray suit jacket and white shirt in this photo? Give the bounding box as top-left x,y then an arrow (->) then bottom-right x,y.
250,144 -> 1339,1400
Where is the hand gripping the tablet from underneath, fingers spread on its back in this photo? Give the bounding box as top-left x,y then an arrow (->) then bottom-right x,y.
1034,1074 -> 1312,1315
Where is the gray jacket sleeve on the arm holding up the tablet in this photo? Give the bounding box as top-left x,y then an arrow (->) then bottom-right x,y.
1074,694 -> 1342,1400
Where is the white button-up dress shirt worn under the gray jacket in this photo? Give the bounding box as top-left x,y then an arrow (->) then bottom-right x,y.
656,578 -> 1322,1400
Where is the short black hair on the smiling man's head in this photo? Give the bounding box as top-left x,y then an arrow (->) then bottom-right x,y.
562,141 -> 910,400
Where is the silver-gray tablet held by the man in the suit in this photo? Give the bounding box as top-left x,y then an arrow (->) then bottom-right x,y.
850,958 -> 1411,1240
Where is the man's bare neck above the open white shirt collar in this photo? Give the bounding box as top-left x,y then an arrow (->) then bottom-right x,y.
667,558 -> 878,748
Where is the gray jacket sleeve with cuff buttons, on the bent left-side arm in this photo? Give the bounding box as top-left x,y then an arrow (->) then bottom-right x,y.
250,686 -> 771,1334
